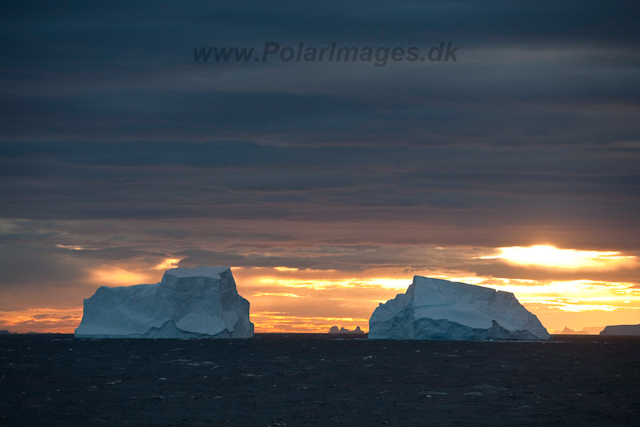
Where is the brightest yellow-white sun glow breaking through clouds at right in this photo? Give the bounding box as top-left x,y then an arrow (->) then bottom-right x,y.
482,245 -> 636,269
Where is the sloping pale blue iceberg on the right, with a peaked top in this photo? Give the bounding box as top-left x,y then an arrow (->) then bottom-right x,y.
369,276 -> 551,340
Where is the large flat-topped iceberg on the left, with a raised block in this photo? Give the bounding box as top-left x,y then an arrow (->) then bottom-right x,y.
75,267 -> 253,338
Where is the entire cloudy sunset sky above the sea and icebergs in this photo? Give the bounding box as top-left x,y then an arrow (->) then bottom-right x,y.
0,1 -> 640,333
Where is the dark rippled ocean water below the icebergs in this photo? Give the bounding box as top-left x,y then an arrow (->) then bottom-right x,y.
0,334 -> 640,426
